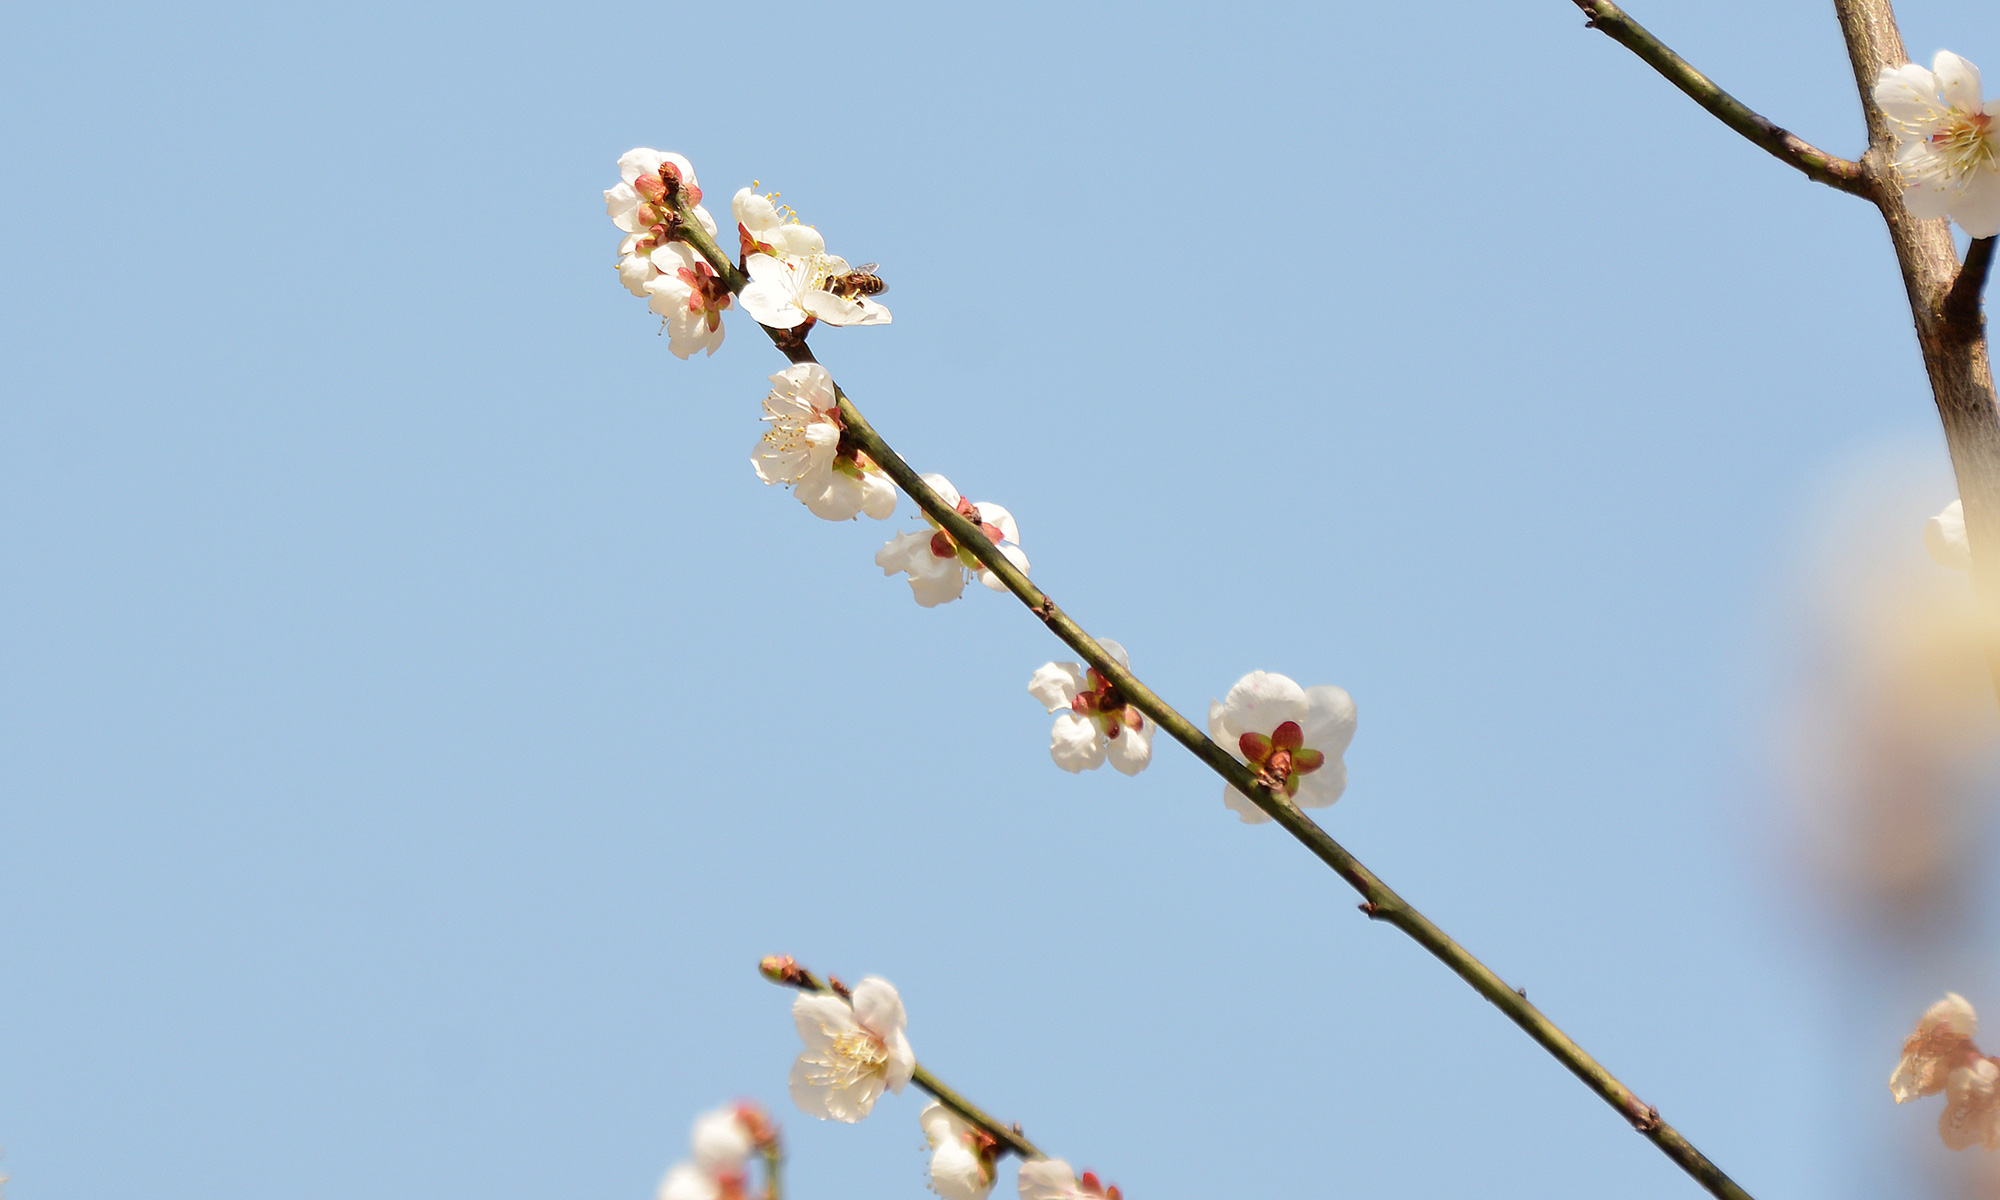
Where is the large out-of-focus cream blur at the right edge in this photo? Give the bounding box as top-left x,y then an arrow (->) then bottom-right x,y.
1780,472 -> 2000,924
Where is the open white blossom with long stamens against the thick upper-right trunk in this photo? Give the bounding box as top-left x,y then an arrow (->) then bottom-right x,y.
1874,50 -> 2000,238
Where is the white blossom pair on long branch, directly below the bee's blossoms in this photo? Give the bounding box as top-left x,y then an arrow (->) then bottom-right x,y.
750,362 -> 896,520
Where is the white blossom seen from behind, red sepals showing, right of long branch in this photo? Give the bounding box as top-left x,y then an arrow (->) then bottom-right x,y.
1208,670 -> 1354,824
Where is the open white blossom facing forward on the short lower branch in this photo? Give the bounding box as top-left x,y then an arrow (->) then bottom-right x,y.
792,976 -> 916,1122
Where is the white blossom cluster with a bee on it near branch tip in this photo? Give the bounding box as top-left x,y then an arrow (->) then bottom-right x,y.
730,188 -> 890,330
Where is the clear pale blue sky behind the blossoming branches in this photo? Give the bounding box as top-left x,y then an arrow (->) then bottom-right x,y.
0,0 -> 2000,1200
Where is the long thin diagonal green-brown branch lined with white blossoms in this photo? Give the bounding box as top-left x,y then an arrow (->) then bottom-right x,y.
682,202 -> 1750,1200
